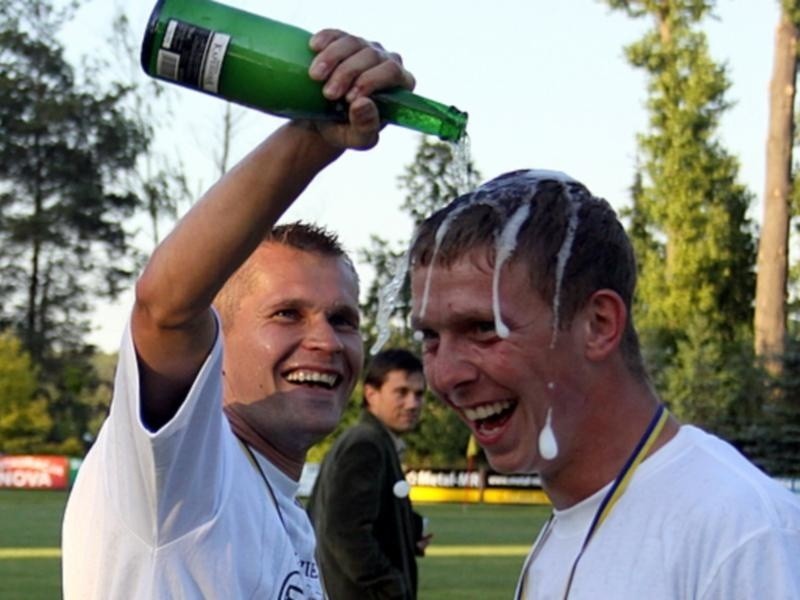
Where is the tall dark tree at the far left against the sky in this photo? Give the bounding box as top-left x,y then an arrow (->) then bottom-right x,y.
0,0 -> 147,363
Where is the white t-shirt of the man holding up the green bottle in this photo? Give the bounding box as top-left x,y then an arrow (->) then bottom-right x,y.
62,328 -> 322,600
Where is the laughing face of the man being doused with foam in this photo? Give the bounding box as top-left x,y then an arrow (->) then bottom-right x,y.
411,248 -> 584,475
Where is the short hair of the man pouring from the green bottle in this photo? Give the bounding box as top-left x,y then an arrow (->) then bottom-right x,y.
214,221 -> 358,328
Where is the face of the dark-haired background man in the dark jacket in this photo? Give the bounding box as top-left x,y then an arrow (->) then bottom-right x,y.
364,369 -> 425,433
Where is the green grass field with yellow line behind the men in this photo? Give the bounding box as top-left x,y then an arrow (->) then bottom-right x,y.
0,490 -> 549,600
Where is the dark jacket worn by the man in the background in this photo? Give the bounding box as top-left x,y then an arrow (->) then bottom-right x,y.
308,411 -> 422,600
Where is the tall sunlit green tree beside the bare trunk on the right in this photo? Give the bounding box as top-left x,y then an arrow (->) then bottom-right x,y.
607,0 -> 755,428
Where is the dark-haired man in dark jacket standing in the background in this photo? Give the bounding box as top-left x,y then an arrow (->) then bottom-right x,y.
309,348 -> 430,600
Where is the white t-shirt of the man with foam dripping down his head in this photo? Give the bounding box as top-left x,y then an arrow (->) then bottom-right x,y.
517,426 -> 800,600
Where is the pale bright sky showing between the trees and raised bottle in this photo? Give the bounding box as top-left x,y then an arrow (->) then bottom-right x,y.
63,0 -> 778,351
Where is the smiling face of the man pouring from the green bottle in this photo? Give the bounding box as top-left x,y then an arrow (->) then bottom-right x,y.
224,243 -> 363,460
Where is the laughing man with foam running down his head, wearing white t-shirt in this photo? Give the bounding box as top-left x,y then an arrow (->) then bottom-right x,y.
409,171 -> 800,600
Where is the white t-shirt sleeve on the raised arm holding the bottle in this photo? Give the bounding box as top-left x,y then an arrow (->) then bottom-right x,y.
98,315 -> 231,546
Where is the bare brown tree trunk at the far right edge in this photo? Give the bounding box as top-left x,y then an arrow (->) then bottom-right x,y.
754,11 -> 798,375
